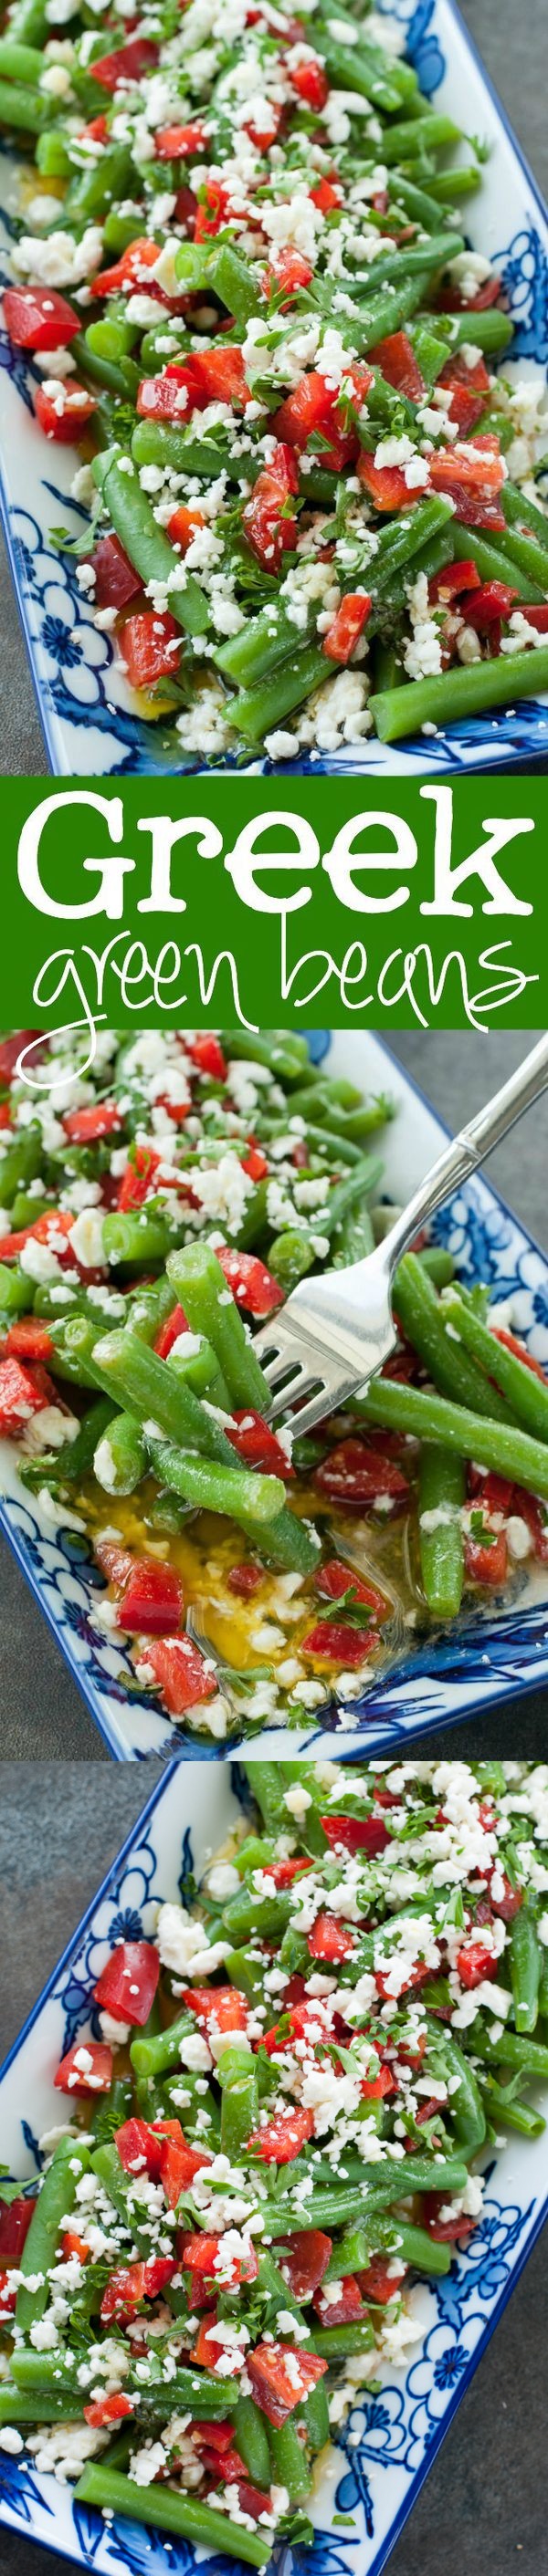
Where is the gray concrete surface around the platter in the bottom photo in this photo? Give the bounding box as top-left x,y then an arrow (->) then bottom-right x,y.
0,1762 -> 548,2576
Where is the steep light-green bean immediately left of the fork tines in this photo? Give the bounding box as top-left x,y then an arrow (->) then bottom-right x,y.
167,1245 -> 268,1412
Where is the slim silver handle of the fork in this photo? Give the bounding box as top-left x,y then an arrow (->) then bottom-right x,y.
375,1036 -> 548,1275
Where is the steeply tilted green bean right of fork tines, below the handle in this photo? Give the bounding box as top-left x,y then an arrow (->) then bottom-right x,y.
394,1252 -> 507,1422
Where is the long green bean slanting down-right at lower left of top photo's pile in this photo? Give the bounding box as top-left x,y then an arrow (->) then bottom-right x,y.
92,448 -> 208,636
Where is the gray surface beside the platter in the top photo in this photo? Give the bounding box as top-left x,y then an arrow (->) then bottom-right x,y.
0,0 -> 548,778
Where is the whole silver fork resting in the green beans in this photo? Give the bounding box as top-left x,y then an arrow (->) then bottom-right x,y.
252,1036 -> 548,1434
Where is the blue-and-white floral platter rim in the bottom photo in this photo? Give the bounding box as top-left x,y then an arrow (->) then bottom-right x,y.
0,1762 -> 548,2576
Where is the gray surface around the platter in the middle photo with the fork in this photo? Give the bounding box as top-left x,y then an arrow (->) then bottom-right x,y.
0,1027 -> 548,1762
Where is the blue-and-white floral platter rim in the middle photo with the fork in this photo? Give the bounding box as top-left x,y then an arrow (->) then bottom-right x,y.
0,1030 -> 548,1762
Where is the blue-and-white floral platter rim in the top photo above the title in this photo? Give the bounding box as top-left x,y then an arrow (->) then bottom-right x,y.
0,0 -> 548,778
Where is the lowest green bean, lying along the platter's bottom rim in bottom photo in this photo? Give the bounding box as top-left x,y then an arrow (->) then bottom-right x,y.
75,2460 -> 273,2569
